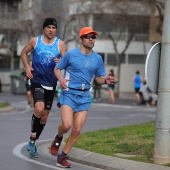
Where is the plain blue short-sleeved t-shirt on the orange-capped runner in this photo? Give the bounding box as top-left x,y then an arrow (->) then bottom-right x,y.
56,48 -> 106,89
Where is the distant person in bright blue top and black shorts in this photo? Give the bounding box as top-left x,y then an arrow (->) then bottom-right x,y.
132,71 -> 143,104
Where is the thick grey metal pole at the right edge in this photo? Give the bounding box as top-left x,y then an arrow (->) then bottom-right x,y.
154,0 -> 170,164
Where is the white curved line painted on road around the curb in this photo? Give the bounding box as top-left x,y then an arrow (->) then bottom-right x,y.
13,140 -> 63,170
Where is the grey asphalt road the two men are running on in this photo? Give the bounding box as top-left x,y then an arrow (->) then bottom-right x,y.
0,93 -> 156,170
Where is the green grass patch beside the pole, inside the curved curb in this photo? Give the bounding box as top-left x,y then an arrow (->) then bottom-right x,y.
65,121 -> 170,166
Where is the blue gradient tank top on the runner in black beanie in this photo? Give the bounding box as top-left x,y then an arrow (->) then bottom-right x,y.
32,35 -> 60,87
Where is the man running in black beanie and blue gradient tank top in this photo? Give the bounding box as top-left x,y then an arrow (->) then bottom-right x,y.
21,18 -> 66,157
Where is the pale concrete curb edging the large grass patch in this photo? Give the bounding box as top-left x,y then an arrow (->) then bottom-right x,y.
38,142 -> 169,170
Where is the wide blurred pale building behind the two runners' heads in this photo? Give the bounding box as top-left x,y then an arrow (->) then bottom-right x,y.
0,0 -> 164,95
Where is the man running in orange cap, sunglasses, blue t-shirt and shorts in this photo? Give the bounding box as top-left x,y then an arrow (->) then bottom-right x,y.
50,27 -> 114,168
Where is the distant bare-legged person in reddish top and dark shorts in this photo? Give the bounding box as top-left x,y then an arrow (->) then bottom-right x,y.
108,69 -> 118,104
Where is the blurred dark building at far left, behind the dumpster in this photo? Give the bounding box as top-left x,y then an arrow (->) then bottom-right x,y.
0,0 -> 21,91
